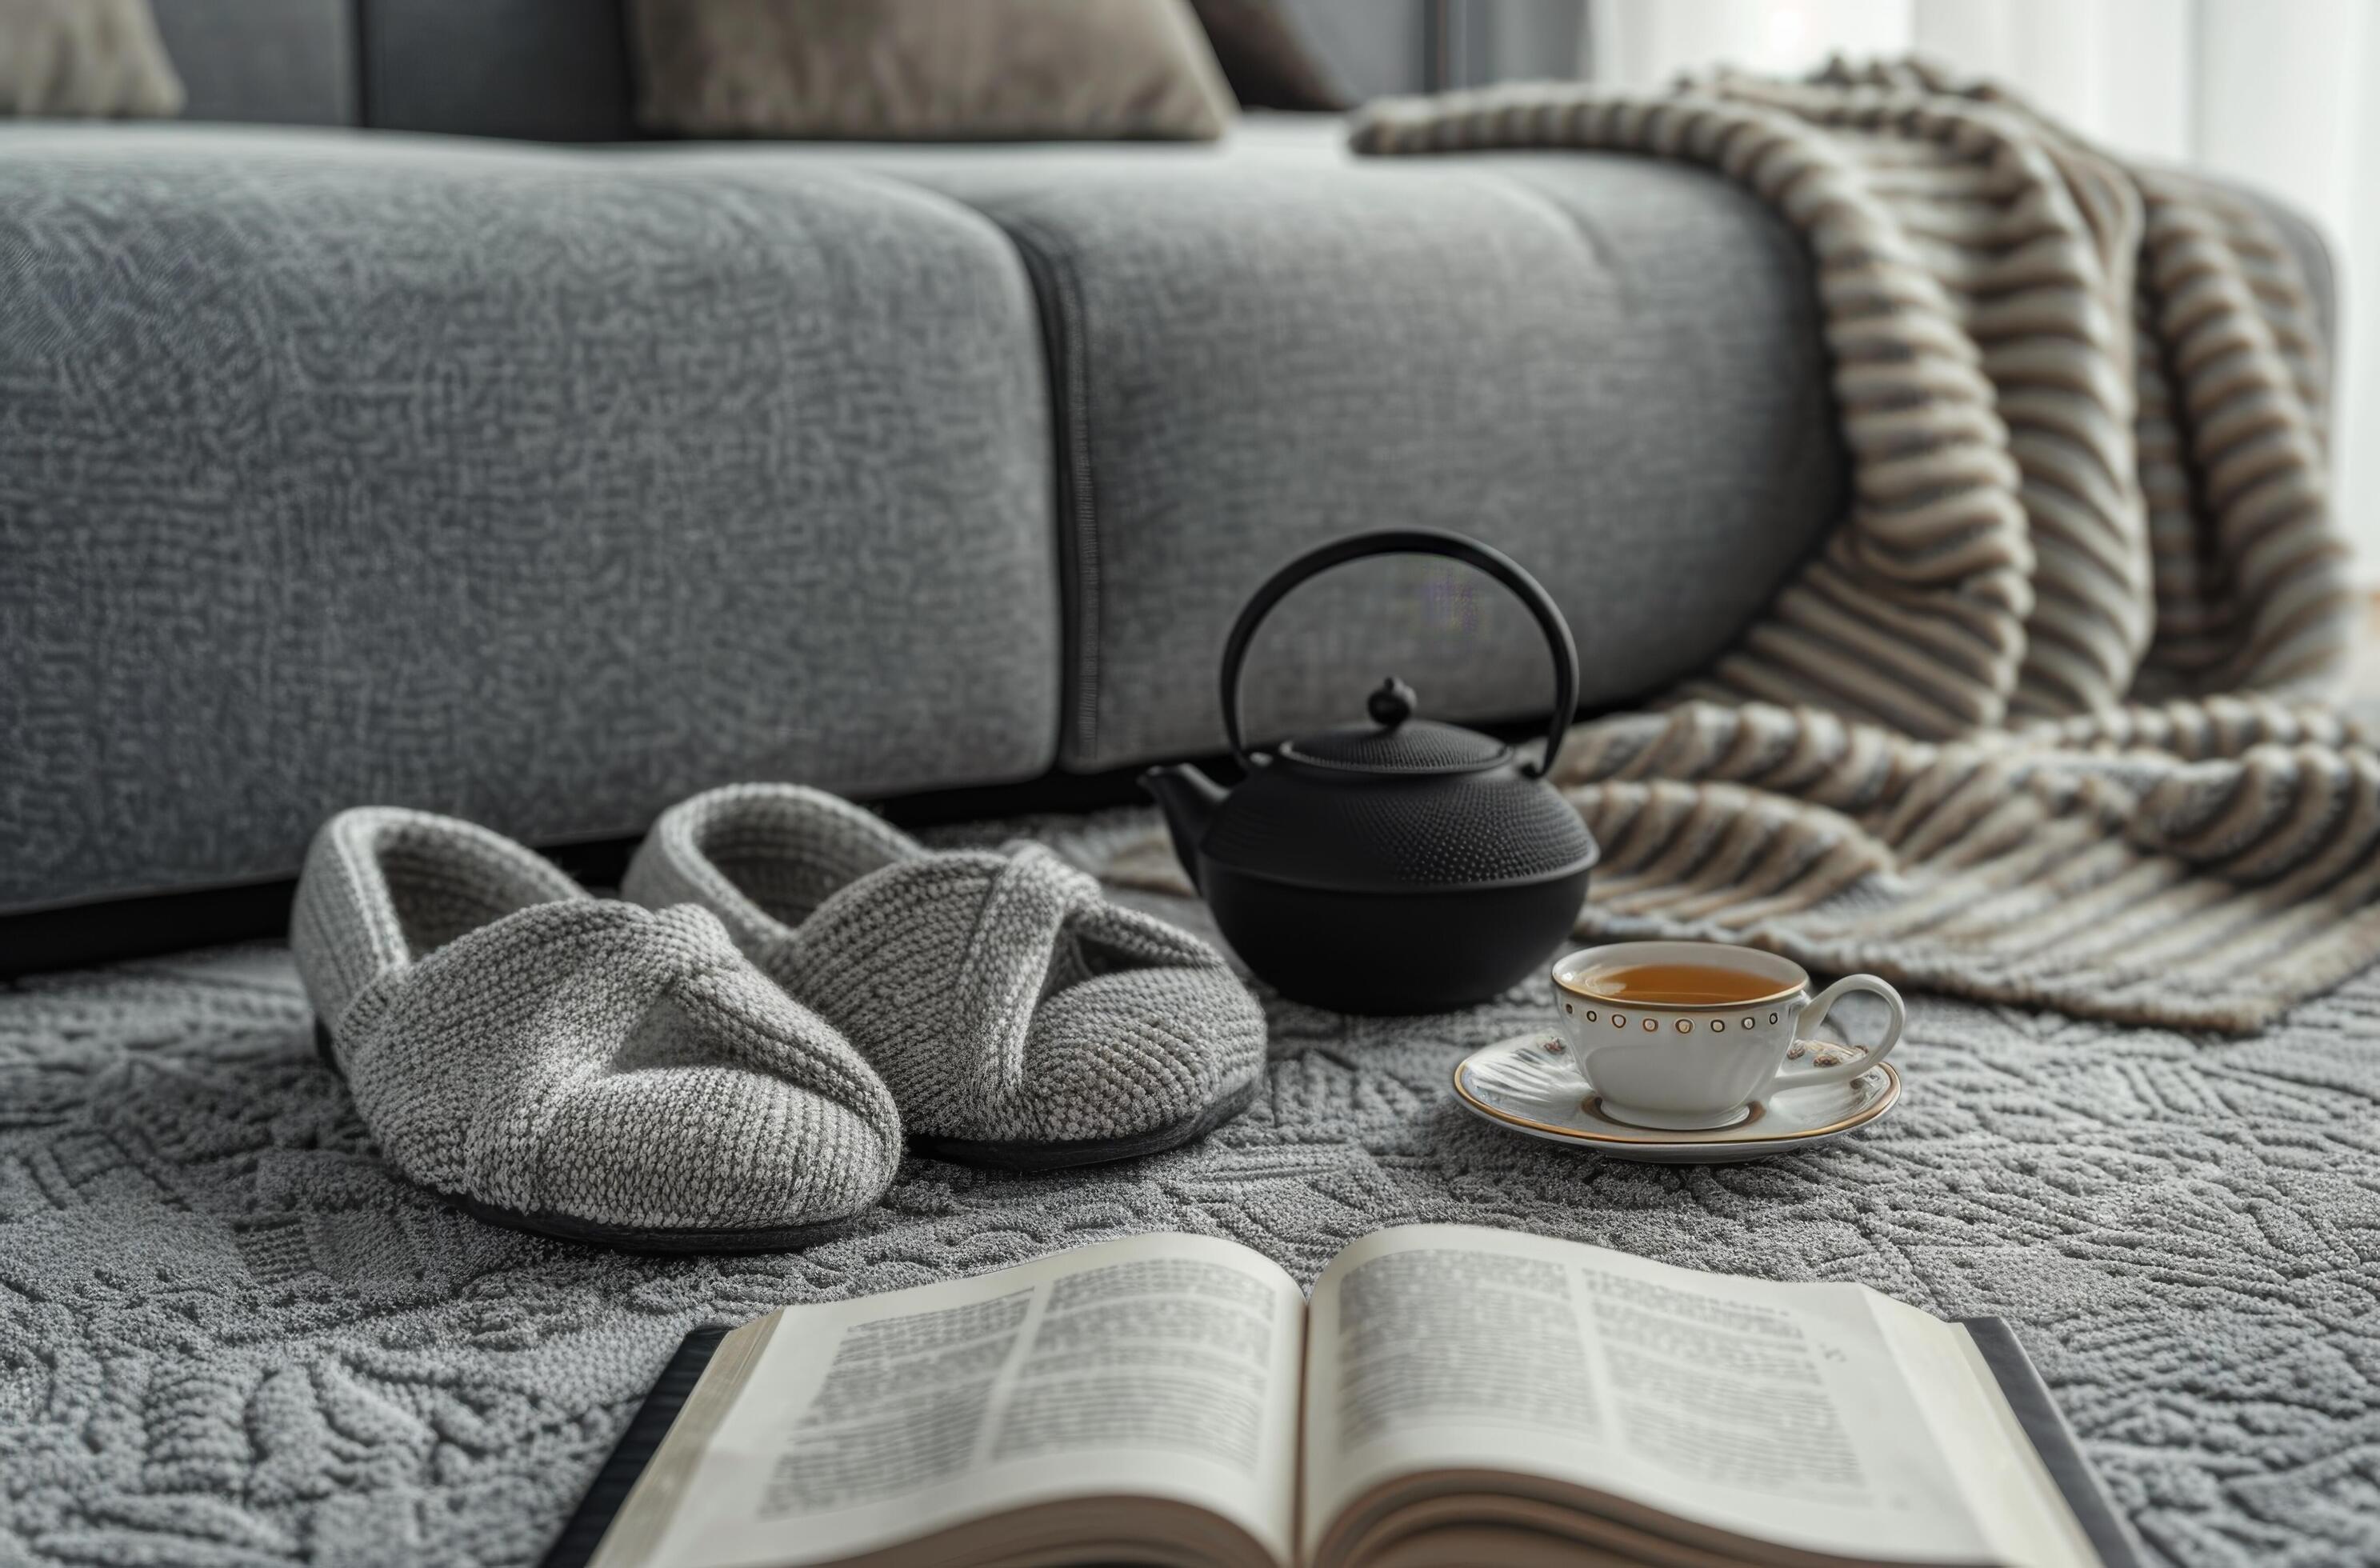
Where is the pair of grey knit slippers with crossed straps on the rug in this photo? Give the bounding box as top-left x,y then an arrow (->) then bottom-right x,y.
290,785 -> 1264,1249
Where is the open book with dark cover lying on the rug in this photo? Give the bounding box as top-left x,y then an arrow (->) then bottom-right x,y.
547,1226 -> 2130,1568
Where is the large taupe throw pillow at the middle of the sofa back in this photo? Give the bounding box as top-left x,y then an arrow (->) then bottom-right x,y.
633,0 -> 1233,140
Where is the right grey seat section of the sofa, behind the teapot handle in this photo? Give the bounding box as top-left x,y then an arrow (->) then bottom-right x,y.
674,127 -> 1845,769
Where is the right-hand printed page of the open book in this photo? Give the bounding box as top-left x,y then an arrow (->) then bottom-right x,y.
1304,1226 -> 2085,1563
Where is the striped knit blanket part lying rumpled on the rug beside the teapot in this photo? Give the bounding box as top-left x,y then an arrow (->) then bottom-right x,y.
1080,697 -> 2380,1030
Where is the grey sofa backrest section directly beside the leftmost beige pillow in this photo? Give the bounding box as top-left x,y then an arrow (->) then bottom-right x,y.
150,0 -> 359,126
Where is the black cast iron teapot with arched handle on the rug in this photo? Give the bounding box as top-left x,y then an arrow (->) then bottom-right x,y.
1140,528 -> 1597,1014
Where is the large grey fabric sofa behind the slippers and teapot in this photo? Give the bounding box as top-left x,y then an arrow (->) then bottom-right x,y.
0,0 -> 2328,964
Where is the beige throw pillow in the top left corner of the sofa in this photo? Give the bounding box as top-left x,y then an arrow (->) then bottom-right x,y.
0,0 -> 181,119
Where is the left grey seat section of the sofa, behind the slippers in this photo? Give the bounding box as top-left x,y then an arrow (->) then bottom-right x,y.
0,129 -> 1059,909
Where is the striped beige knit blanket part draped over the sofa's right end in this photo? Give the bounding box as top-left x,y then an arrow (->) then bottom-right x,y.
1354,62 -> 2354,740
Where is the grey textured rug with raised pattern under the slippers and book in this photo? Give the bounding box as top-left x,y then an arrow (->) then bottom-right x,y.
0,818 -> 2380,1566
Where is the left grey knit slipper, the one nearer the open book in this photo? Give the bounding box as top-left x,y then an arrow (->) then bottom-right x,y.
290,806 -> 902,1251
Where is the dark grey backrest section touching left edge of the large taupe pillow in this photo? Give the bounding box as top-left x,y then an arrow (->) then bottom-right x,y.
357,0 -> 635,140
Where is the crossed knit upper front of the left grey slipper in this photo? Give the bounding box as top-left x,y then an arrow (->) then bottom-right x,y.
347,899 -> 898,1228
